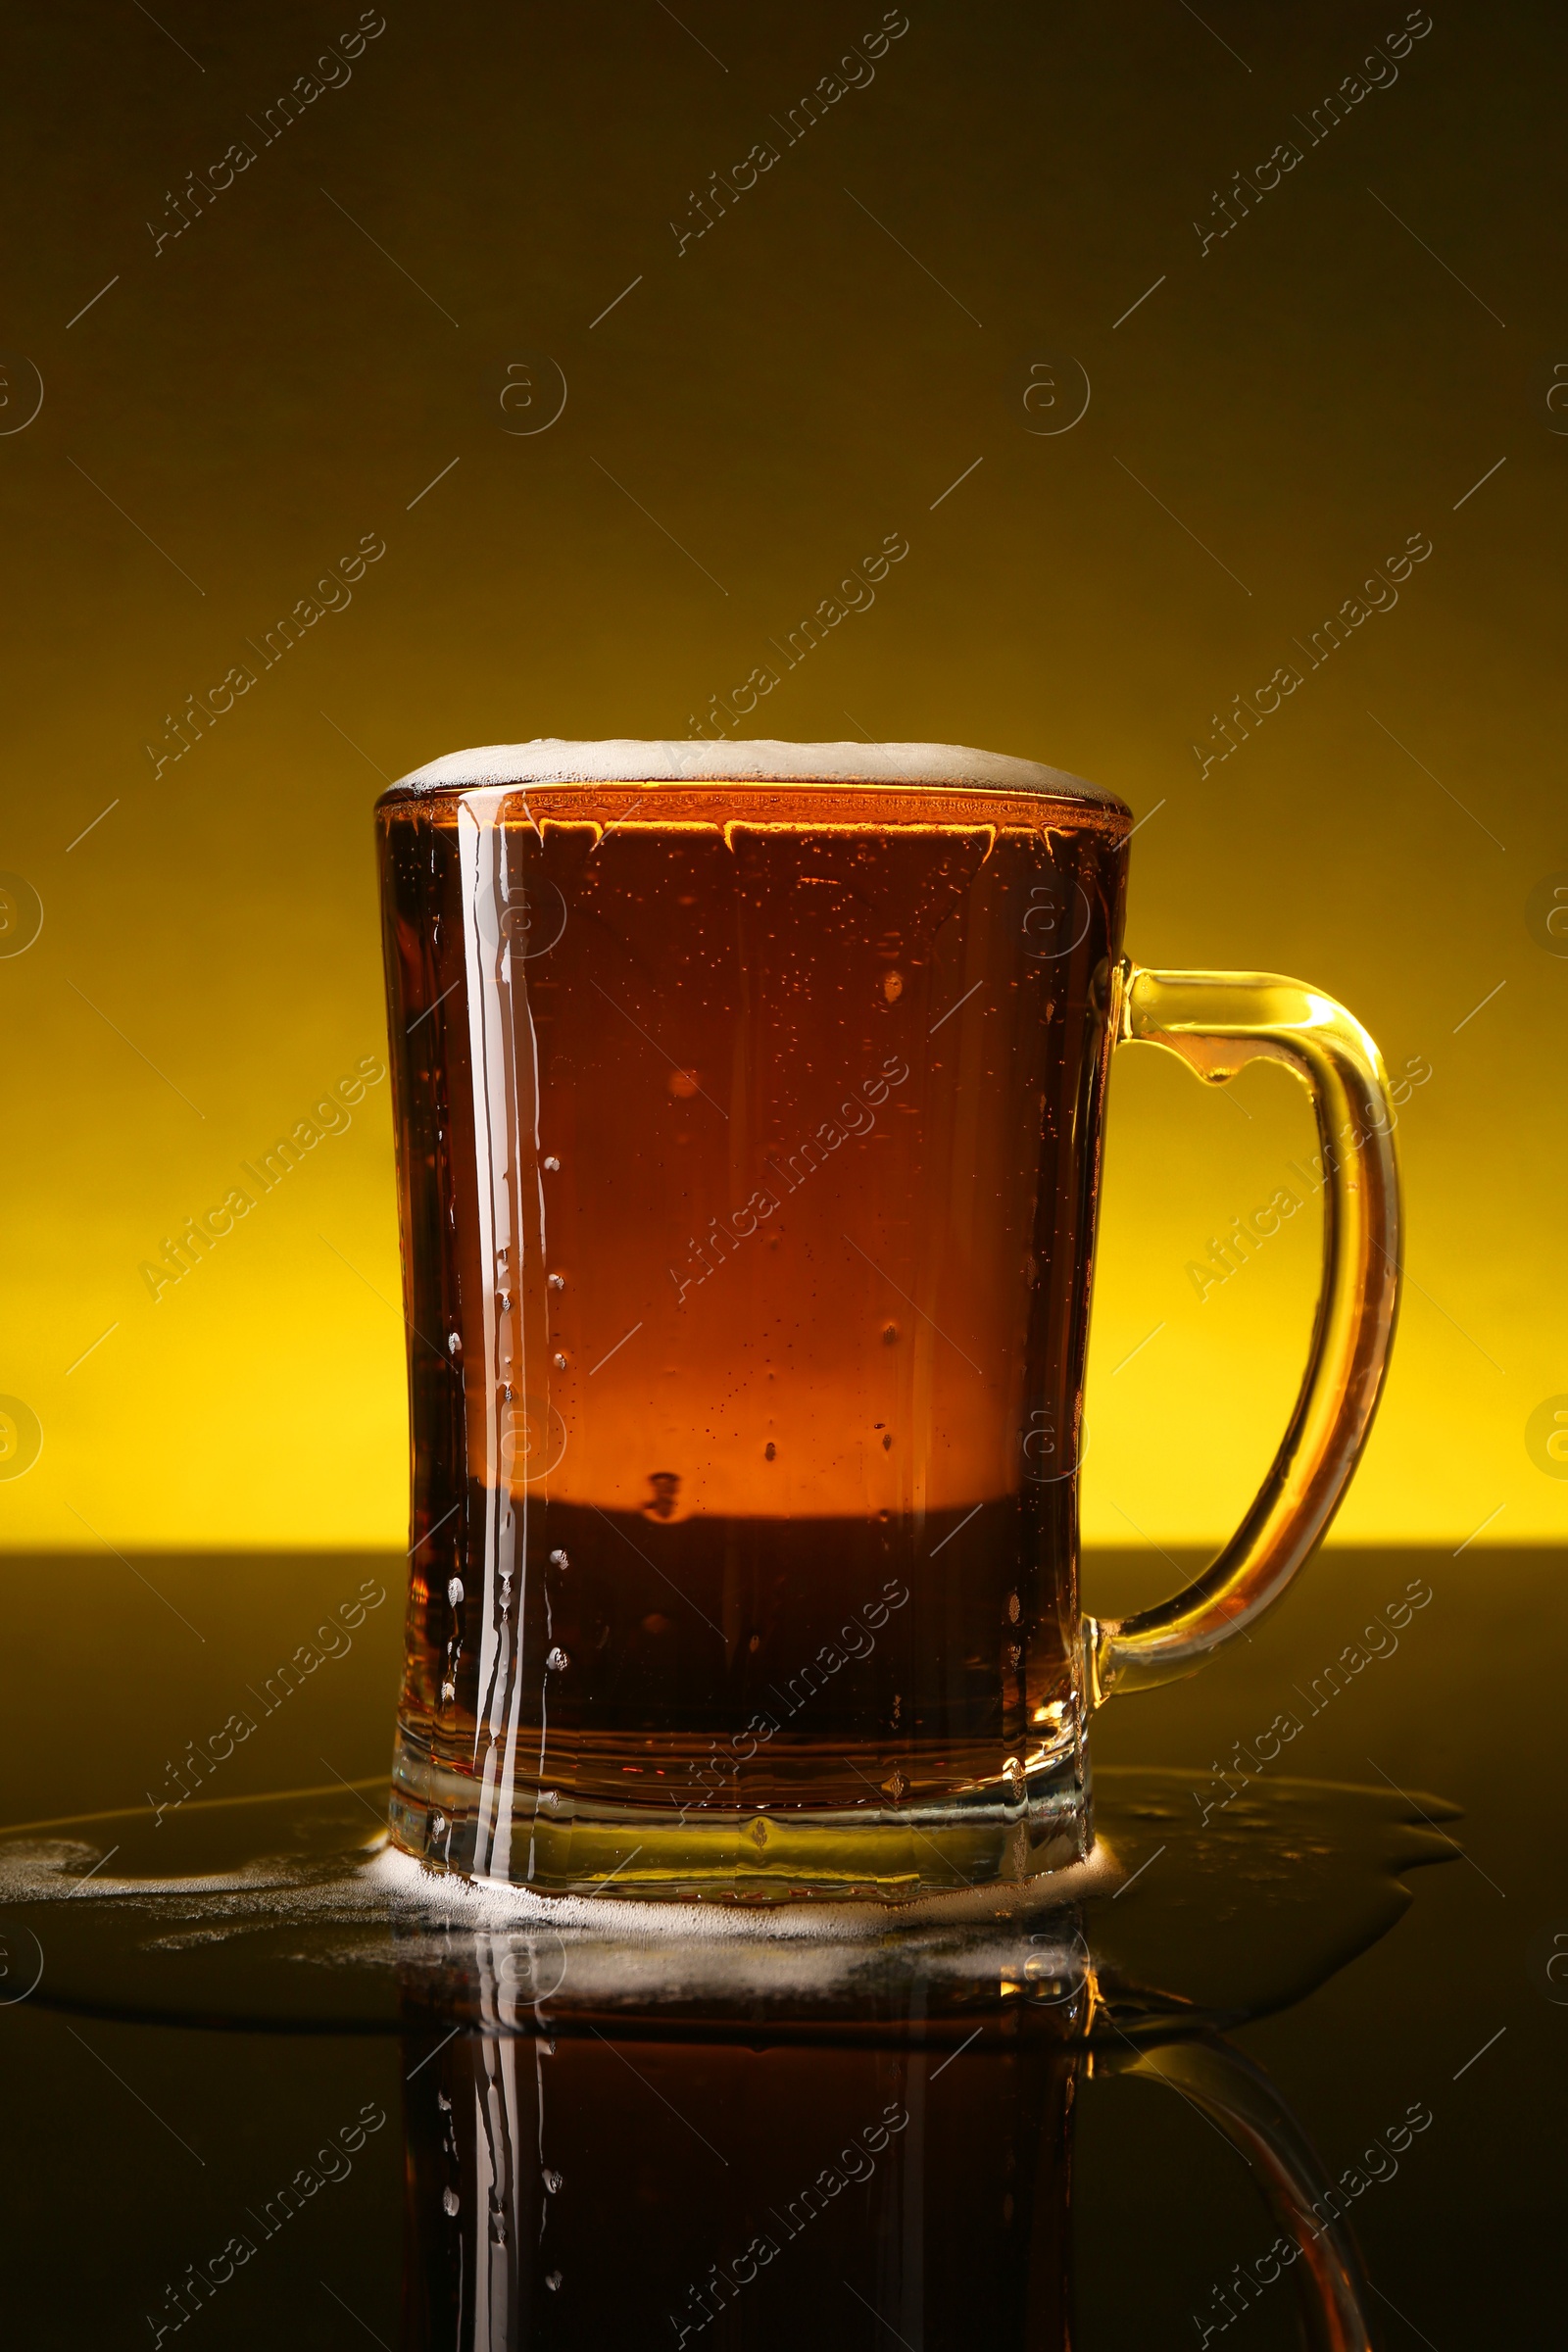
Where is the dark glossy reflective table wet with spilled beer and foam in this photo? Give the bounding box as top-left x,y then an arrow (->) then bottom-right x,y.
0,1552 -> 1568,2352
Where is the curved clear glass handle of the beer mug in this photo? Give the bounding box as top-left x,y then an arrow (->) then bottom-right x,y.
1084,962 -> 1398,1705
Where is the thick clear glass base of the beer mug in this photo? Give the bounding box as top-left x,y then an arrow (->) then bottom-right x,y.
390,1739 -> 1093,1903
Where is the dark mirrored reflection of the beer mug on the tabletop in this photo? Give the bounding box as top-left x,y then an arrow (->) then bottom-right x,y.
402,1989 -> 1371,2352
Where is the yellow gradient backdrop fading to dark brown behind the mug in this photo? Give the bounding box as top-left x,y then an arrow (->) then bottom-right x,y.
0,0 -> 1568,1547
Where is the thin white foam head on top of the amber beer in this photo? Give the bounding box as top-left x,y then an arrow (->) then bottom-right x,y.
393,736 -> 1124,809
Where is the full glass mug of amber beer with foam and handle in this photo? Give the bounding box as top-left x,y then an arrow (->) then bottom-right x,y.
378,743 -> 1398,1898
